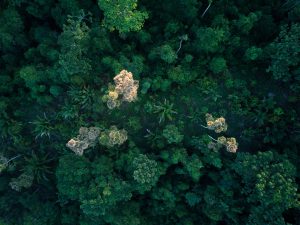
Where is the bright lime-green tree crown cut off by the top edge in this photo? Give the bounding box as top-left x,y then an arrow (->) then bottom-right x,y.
98,0 -> 148,33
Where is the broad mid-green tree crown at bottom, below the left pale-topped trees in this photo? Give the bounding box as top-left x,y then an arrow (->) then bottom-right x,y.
80,156 -> 133,222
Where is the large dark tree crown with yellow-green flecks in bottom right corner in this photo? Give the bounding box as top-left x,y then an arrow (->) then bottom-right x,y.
232,151 -> 300,224
